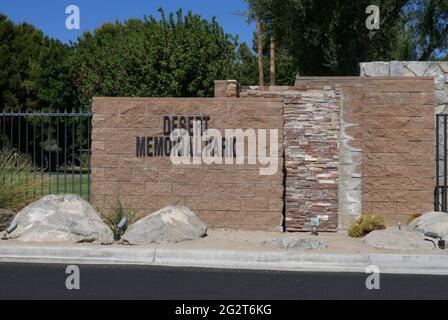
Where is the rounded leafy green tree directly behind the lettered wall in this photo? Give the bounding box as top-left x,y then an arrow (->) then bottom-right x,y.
75,10 -> 237,103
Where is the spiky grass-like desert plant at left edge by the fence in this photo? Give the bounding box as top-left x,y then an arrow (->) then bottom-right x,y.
0,149 -> 48,212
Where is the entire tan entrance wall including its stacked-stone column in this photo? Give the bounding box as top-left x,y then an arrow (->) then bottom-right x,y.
92,77 -> 436,231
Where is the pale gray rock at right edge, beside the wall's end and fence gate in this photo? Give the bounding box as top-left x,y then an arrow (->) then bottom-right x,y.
408,212 -> 448,240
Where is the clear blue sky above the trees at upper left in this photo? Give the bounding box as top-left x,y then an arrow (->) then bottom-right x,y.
0,0 -> 255,45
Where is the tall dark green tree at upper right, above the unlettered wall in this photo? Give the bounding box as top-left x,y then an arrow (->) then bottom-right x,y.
251,0 -> 447,75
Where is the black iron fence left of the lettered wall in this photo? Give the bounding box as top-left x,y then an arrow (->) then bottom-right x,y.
0,111 -> 92,200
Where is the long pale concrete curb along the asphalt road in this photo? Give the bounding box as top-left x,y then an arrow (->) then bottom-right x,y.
0,244 -> 448,275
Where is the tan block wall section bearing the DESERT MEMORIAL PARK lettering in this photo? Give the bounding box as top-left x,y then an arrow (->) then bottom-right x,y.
92,98 -> 284,230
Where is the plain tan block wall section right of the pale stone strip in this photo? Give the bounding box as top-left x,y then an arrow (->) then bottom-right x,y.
363,78 -> 435,224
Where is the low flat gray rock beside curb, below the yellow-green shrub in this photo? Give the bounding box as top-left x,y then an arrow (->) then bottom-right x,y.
364,230 -> 434,251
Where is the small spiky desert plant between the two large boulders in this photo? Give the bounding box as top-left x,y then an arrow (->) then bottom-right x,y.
101,194 -> 140,236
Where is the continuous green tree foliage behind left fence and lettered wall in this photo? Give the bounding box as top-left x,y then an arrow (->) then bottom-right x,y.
0,10 -> 237,111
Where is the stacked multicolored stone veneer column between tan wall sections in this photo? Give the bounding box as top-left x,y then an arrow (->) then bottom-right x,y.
284,88 -> 340,231
